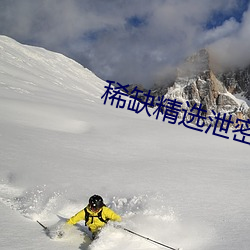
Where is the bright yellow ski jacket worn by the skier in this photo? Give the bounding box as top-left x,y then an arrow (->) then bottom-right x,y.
67,206 -> 122,233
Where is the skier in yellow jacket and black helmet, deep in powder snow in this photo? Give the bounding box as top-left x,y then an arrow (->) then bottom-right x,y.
67,194 -> 122,239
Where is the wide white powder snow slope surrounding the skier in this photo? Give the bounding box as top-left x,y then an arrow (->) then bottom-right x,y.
0,36 -> 250,250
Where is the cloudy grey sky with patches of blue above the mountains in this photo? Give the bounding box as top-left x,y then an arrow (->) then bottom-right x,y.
0,0 -> 250,87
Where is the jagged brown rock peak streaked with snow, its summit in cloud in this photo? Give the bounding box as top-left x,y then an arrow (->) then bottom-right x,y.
165,49 -> 250,119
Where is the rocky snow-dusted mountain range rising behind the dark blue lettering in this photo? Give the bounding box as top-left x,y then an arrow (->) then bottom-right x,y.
127,49 -> 250,127
